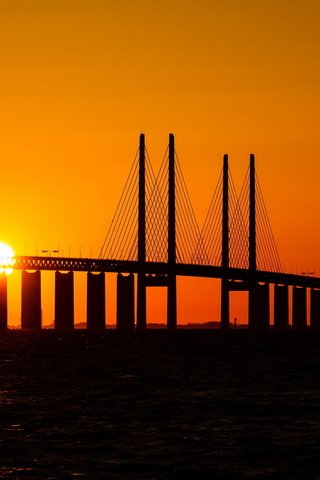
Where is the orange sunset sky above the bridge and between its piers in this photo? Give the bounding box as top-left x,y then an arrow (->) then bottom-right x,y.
0,0 -> 320,324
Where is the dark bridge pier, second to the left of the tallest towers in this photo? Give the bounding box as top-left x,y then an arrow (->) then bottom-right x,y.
87,272 -> 106,330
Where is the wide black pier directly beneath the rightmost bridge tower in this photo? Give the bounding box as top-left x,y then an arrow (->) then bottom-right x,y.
248,283 -> 270,330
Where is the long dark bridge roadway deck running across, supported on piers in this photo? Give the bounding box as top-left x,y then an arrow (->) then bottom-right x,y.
12,256 -> 320,288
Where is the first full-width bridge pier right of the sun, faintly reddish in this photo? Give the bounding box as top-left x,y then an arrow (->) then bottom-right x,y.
21,270 -> 41,330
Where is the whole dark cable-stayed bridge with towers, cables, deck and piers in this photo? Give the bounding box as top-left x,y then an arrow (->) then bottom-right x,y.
0,134 -> 320,330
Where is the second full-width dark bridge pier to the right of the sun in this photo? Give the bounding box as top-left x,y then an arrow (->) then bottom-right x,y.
54,271 -> 74,330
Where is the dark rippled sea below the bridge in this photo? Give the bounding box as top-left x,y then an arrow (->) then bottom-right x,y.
0,329 -> 320,480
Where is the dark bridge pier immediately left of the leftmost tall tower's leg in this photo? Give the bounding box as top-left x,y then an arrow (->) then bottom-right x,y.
117,273 -> 134,330
